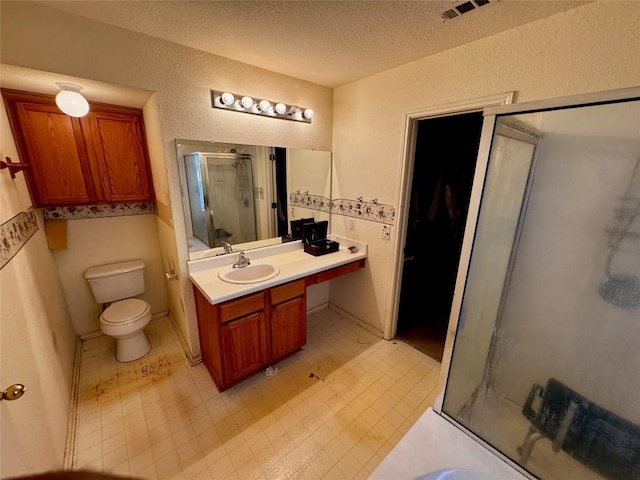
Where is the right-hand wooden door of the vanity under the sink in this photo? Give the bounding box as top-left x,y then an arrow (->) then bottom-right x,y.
271,296 -> 307,360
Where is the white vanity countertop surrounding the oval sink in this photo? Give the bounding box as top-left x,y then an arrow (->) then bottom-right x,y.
187,235 -> 367,305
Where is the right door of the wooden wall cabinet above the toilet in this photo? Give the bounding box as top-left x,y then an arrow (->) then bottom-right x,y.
82,108 -> 153,203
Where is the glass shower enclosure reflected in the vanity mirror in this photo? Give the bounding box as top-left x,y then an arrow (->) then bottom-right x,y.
184,152 -> 257,248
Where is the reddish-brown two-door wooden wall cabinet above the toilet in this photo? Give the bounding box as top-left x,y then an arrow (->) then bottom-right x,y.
2,89 -> 154,207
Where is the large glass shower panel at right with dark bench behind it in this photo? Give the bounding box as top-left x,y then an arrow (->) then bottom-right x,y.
442,94 -> 640,480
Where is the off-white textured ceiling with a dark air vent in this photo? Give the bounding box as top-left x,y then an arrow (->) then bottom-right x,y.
38,0 -> 589,87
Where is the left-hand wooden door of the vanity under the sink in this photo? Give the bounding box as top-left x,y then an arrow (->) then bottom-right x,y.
221,311 -> 268,385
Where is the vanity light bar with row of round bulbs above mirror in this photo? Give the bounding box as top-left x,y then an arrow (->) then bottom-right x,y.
211,90 -> 313,123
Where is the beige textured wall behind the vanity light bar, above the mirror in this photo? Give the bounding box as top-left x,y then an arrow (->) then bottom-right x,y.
1,2 -> 333,357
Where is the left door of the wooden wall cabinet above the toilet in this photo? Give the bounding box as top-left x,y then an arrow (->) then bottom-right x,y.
3,91 -> 96,207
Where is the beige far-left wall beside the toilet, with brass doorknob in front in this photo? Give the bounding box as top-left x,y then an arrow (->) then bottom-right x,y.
0,94 -> 76,478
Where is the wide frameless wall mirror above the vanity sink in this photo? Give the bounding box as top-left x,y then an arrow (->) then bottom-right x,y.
175,139 -> 332,260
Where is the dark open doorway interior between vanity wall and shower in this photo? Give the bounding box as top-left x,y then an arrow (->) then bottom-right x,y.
396,112 -> 482,362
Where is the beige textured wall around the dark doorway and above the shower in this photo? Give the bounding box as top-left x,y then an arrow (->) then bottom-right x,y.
331,2 -> 640,338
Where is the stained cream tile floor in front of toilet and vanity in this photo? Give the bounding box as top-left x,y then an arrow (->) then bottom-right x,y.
73,309 -> 440,480
